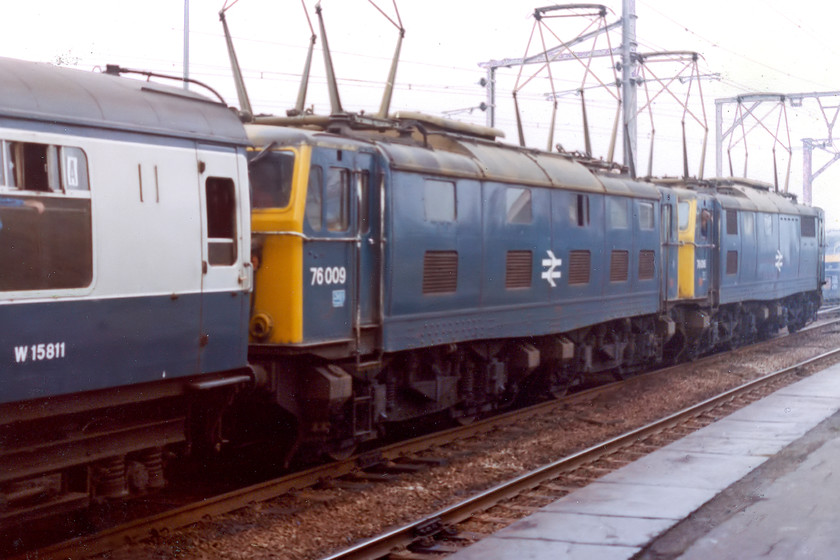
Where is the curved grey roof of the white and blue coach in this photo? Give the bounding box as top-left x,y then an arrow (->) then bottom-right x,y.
0,58 -> 247,145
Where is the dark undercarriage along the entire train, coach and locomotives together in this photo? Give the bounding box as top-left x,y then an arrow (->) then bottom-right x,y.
0,292 -> 820,524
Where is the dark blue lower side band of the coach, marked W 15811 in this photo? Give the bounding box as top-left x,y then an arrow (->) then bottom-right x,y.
0,292 -> 249,403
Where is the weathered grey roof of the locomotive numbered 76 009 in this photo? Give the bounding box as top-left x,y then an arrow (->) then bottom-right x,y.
246,124 -> 659,199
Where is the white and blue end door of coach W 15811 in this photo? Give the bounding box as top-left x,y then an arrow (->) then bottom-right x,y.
197,147 -> 250,372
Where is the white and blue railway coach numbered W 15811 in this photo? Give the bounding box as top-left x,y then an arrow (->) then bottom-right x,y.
0,59 -> 251,524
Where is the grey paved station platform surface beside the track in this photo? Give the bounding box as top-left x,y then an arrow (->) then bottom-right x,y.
450,365 -> 840,560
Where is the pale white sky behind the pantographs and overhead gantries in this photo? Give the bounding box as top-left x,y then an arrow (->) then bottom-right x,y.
0,0 -> 840,227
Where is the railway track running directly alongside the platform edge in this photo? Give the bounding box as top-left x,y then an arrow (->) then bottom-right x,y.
324,349 -> 840,560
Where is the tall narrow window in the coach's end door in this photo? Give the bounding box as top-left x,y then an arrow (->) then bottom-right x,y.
205,177 -> 236,266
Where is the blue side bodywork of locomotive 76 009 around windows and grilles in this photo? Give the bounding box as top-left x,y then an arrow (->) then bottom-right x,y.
383,171 -> 660,351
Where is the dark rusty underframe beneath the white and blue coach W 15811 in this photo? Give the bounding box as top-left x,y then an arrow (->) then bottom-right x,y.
0,370 -> 253,527
